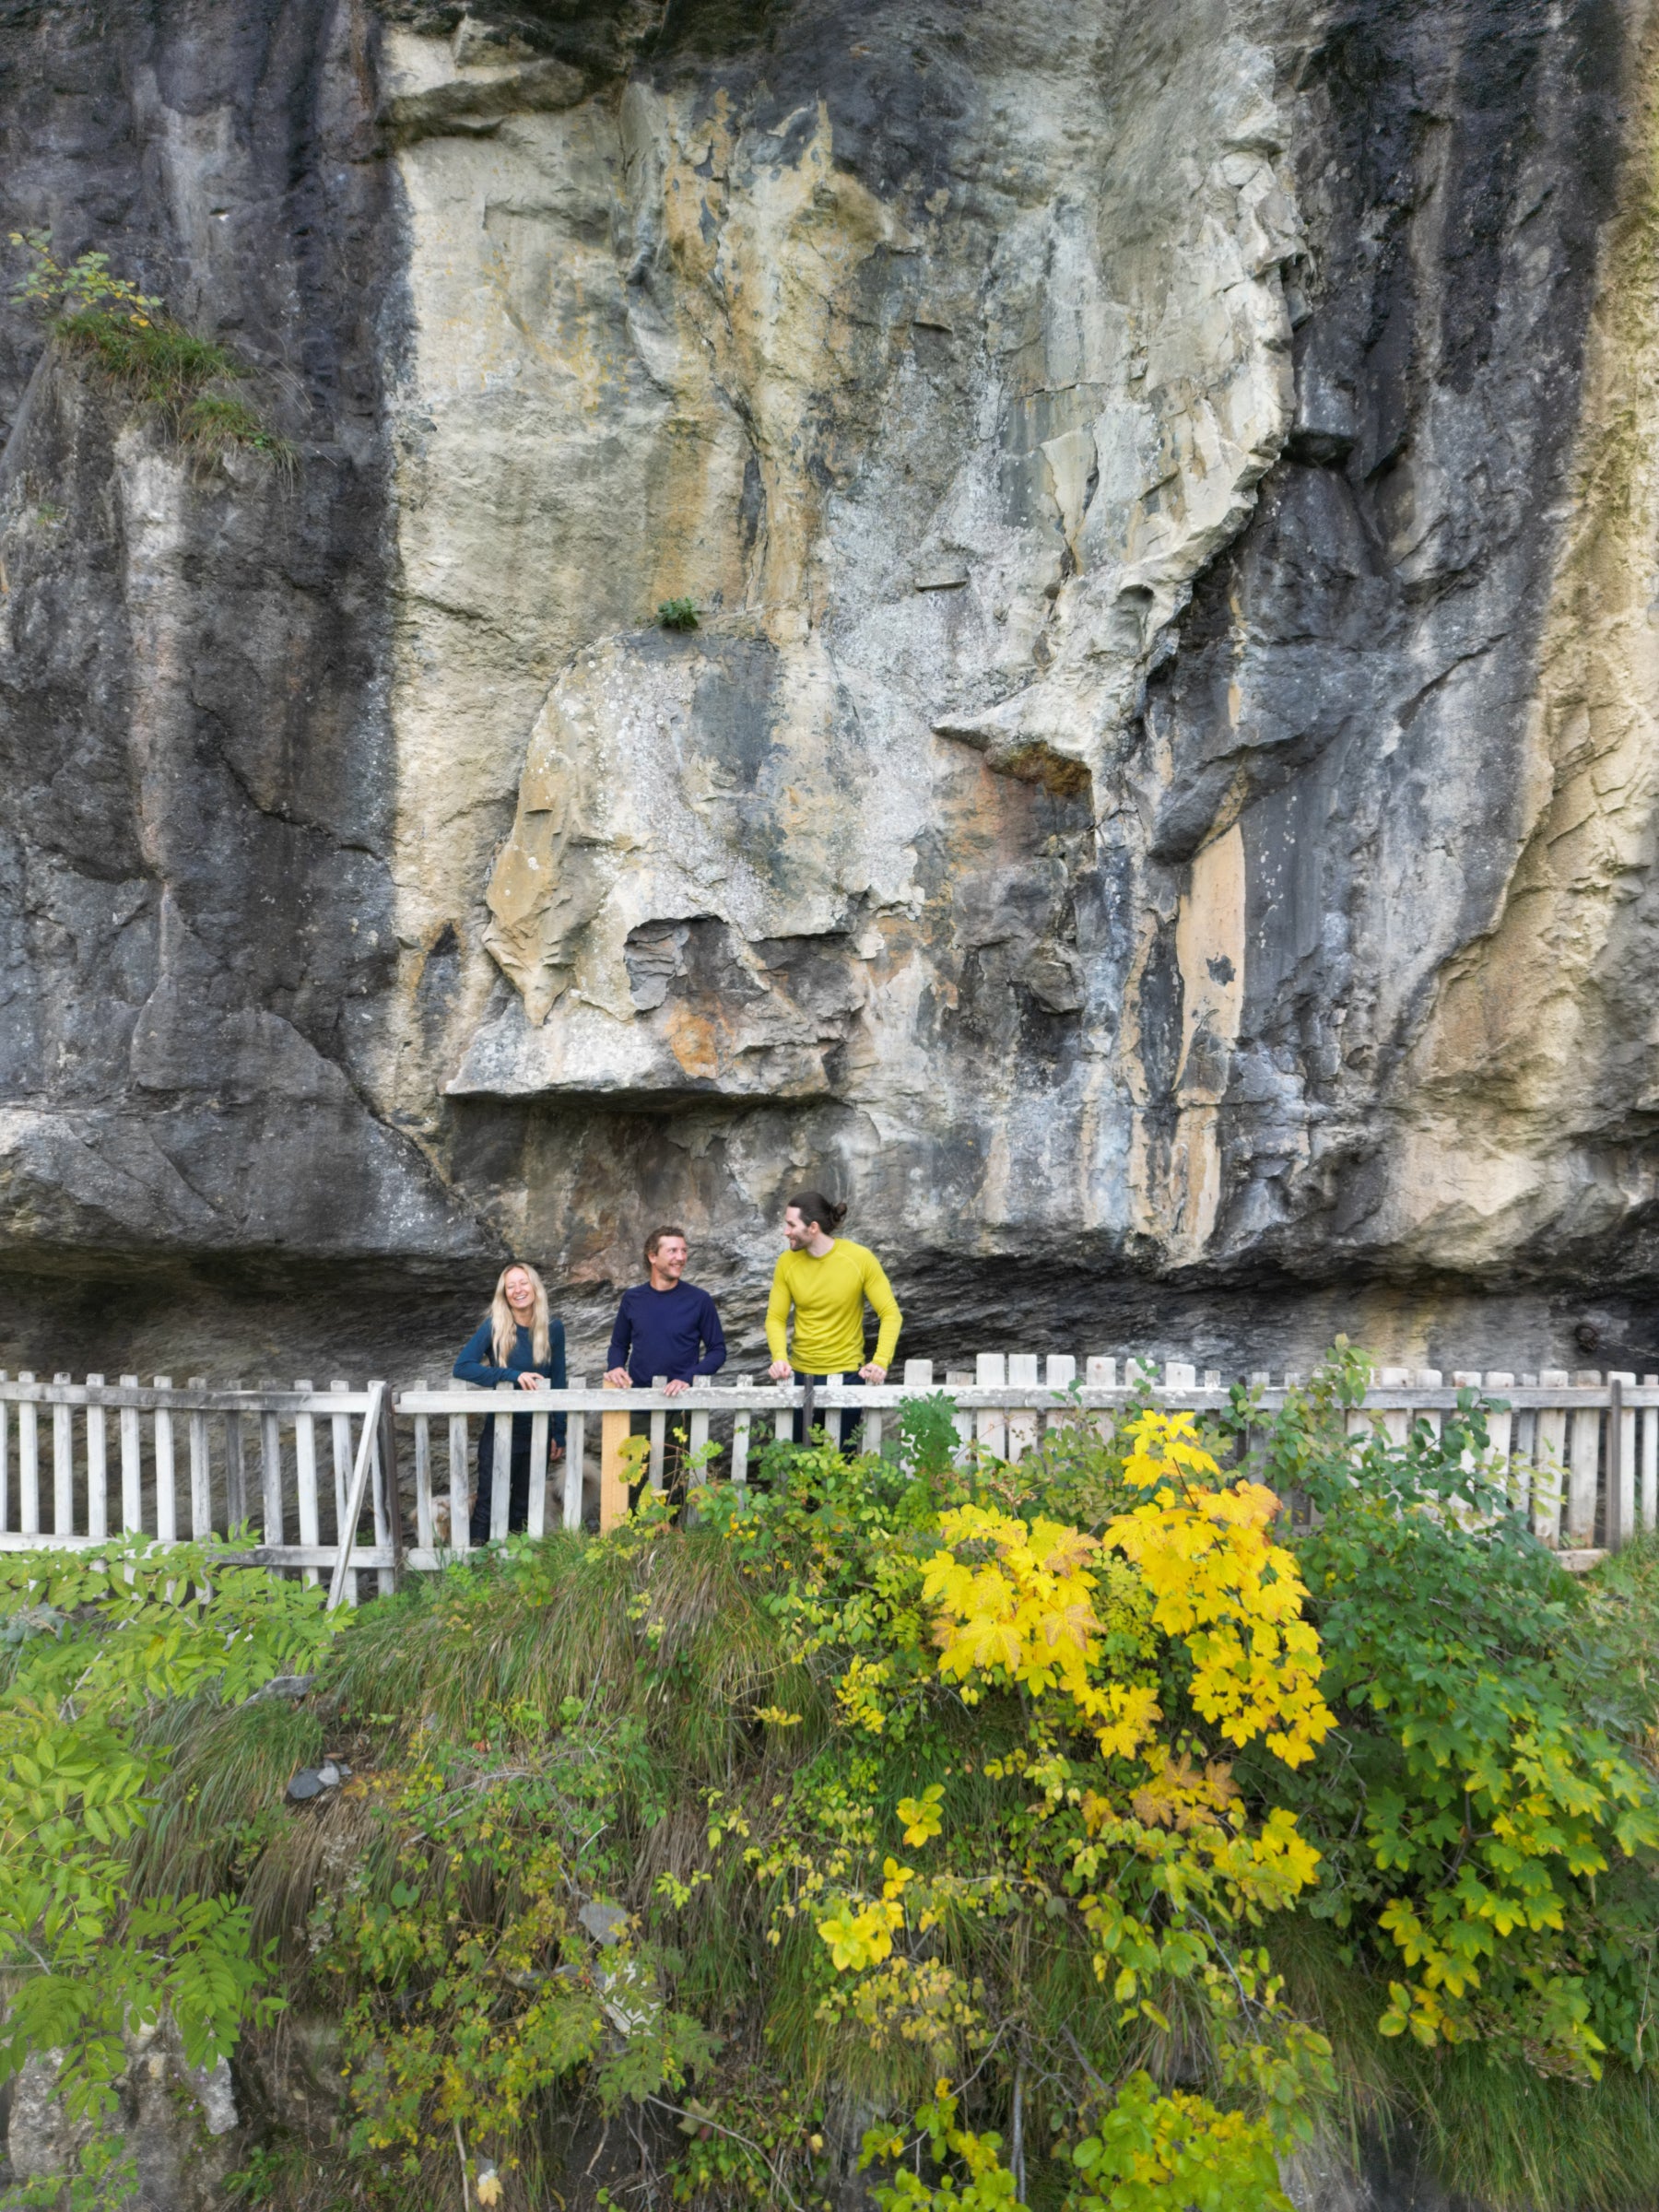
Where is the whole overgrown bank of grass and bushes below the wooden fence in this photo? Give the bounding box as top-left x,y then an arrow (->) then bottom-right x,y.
0,1351 -> 1659,2212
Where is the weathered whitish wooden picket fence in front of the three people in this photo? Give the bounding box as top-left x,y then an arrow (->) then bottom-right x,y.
0,1351 -> 1659,1604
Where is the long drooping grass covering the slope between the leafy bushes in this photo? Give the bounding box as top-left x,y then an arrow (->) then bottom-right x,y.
120,1531 -> 1659,2212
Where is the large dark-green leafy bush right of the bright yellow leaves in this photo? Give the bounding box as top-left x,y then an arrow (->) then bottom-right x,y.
1267,1359 -> 1659,2079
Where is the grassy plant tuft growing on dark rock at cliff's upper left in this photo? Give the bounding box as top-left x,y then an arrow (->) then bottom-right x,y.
11,230 -> 294,466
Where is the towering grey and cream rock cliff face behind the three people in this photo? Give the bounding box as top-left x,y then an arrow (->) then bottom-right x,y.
0,0 -> 1659,1371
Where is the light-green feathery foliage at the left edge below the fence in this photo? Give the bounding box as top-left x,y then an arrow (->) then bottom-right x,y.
0,1542 -> 343,2114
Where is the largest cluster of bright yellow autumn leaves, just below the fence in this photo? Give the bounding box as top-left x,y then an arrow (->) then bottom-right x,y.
818,1411 -> 1334,1971
